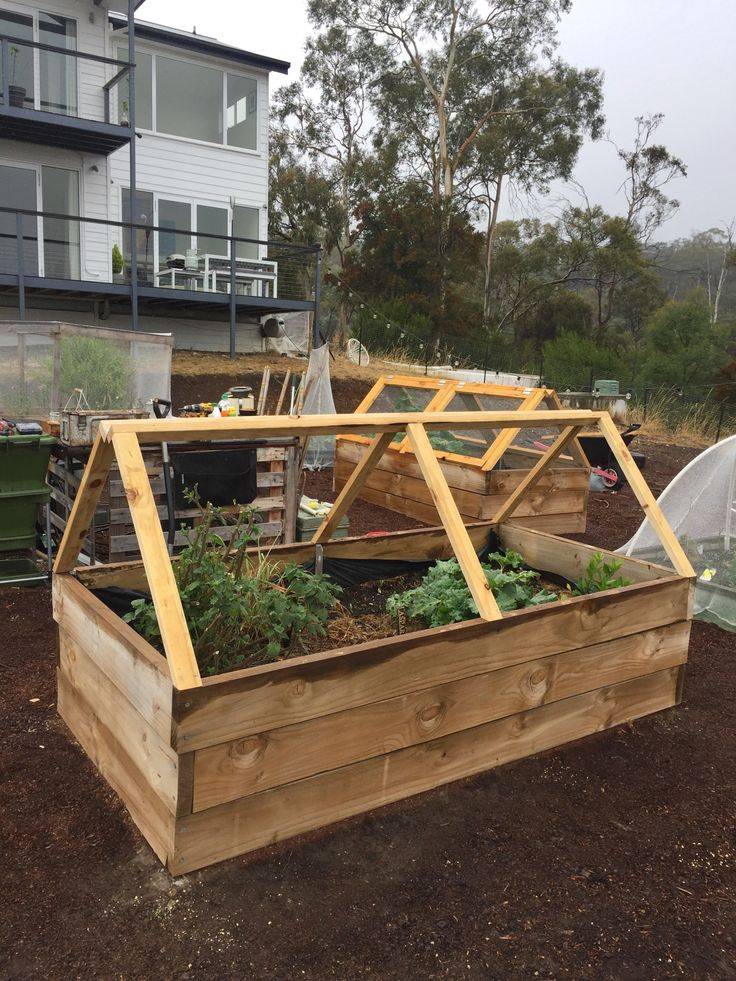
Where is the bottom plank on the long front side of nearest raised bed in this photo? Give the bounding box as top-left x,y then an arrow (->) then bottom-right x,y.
169,668 -> 678,874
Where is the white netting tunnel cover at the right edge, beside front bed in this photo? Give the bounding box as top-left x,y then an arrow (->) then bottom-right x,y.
619,436 -> 736,631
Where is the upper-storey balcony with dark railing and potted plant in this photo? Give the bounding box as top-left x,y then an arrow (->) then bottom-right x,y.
0,34 -> 133,156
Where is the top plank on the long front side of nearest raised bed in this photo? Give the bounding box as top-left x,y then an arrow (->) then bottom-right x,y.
174,578 -> 689,752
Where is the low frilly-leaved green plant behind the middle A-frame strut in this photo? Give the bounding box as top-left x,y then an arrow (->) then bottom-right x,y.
386,551 -> 557,627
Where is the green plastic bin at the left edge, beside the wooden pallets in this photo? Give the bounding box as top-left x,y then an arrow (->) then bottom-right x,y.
0,436 -> 56,585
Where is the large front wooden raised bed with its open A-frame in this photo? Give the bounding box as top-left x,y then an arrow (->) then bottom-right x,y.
54,411 -> 693,873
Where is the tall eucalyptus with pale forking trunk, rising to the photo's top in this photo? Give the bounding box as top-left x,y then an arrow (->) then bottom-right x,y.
309,0 -> 571,326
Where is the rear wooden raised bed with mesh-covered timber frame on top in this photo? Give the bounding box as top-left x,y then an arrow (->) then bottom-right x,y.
334,375 -> 590,534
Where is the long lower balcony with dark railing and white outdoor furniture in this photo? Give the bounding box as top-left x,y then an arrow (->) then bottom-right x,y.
0,208 -> 320,323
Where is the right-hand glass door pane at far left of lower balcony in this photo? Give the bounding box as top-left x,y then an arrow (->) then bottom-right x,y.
41,167 -> 80,279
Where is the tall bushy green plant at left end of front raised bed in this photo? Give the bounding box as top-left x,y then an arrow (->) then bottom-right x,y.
124,505 -> 341,675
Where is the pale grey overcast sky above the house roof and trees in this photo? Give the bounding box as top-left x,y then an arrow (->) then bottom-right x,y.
139,0 -> 736,238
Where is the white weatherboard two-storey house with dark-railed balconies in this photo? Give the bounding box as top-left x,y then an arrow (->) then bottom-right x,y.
0,0 -> 319,350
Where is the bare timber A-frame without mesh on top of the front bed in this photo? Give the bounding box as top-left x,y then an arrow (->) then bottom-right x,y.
54,409 -> 694,691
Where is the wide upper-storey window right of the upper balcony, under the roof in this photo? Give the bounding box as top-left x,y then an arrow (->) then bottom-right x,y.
112,45 -> 258,150
